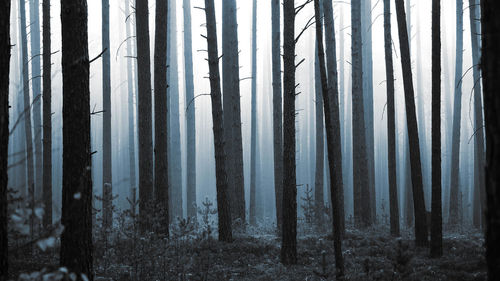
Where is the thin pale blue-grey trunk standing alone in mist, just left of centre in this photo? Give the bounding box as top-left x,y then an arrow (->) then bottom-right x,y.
250,0 -> 257,225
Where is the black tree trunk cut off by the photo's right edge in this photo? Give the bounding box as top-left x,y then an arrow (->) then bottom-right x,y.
481,0 -> 500,281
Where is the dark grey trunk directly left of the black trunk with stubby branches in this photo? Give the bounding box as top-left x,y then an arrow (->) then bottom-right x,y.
271,0 -> 283,231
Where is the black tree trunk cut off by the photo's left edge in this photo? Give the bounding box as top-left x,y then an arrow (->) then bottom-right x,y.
0,0 -> 11,281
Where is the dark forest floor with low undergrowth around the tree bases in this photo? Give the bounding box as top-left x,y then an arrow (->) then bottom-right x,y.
6,220 -> 486,281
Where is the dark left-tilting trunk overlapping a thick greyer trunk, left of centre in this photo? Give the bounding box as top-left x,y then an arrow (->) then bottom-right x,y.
205,0 -> 233,242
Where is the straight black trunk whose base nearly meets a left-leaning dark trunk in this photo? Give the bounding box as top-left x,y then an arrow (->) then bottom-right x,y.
430,0 -> 443,257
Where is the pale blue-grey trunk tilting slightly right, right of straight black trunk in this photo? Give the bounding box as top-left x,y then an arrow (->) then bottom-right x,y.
448,0 -> 464,225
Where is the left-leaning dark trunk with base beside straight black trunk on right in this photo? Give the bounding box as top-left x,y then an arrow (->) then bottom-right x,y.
396,0 -> 428,246
